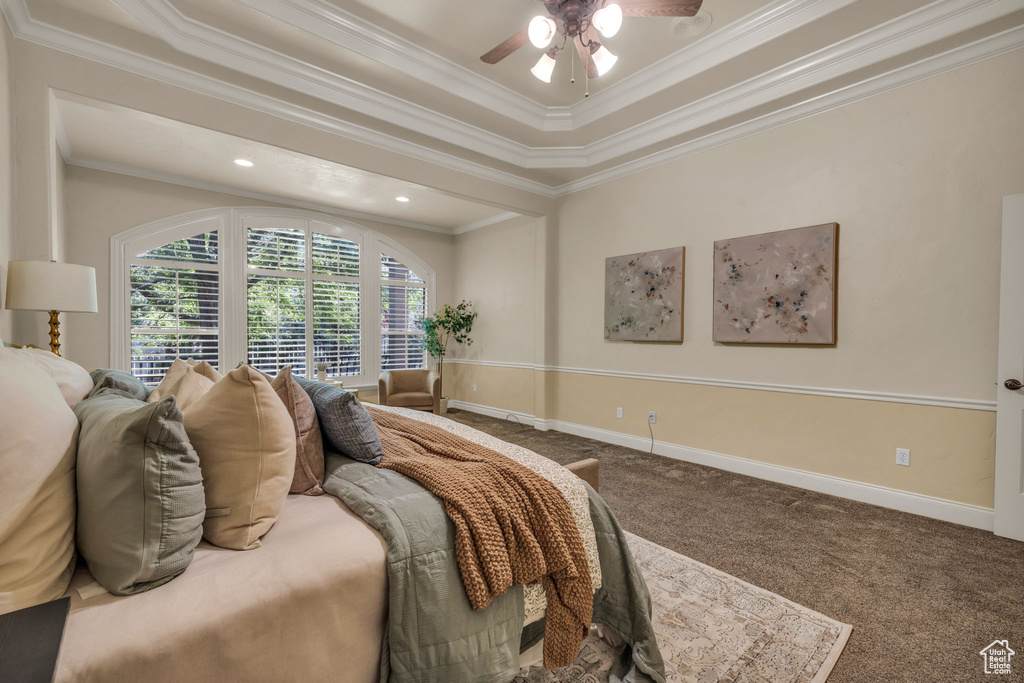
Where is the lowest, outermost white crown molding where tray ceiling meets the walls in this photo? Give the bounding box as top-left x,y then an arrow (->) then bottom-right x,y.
0,0 -> 1024,198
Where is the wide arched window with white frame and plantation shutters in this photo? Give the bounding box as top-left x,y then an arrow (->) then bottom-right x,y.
111,209 -> 434,386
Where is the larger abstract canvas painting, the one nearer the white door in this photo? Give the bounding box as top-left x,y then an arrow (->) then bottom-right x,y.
714,223 -> 839,344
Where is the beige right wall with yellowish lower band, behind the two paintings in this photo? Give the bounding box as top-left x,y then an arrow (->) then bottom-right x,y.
456,50 -> 1024,507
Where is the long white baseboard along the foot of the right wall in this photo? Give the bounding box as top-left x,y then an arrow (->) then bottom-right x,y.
449,400 -> 993,531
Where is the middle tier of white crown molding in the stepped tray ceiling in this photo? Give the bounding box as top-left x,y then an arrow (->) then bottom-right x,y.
113,0 -> 1024,169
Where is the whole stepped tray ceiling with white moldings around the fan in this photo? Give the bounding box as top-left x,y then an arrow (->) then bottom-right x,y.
8,0 -> 1024,197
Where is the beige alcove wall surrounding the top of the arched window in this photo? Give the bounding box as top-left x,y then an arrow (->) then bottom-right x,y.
65,166 -> 455,370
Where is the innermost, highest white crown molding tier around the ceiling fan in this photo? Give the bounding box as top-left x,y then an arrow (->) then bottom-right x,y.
239,0 -> 856,131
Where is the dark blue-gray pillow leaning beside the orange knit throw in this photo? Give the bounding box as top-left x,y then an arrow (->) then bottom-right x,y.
295,377 -> 384,465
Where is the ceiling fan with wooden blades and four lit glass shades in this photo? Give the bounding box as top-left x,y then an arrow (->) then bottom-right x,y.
480,0 -> 703,90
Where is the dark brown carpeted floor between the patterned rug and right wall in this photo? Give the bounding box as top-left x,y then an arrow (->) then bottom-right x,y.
449,411 -> 1024,683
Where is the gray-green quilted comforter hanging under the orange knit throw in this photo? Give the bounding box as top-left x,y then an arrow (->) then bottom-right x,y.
324,454 -> 665,683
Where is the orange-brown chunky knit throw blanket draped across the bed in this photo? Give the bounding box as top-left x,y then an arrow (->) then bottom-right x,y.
367,405 -> 594,669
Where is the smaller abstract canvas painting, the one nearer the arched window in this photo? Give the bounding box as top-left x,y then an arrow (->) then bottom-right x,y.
604,247 -> 686,342
